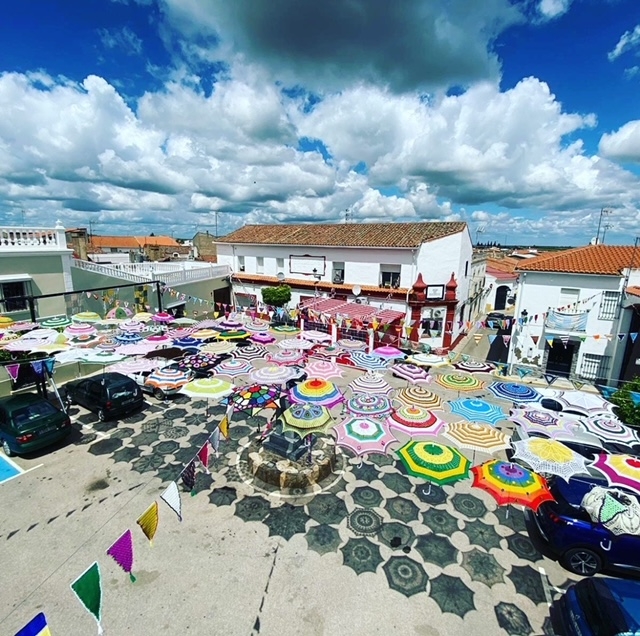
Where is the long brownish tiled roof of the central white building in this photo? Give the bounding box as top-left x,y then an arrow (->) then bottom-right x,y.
218,221 -> 467,248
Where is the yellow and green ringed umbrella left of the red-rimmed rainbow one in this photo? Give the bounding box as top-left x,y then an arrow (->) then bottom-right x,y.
398,440 -> 470,485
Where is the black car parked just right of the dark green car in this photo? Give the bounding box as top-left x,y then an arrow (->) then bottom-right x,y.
65,372 -> 144,421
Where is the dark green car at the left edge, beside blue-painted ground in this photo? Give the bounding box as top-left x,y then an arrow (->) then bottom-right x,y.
0,393 -> 71,457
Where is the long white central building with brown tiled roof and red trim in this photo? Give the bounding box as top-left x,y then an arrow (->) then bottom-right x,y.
217,223 -> 472,347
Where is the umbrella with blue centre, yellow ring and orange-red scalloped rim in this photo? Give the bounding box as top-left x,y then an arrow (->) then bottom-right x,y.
471,459 -> 554,511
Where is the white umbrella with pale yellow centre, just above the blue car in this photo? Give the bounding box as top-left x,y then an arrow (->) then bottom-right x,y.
513,437 -> 588,481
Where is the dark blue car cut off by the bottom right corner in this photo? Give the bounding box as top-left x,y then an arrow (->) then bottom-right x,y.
551,577 -> 640,636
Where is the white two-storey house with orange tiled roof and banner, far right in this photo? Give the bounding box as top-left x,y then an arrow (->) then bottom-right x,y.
508,245 -> 640,383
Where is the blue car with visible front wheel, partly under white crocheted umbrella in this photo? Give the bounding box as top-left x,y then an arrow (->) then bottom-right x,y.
525,476 -> 640,576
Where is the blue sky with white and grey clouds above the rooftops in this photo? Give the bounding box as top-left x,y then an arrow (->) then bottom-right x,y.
0,0 -> 640,245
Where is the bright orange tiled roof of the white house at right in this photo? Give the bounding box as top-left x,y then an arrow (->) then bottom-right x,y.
516,245 -> 640,276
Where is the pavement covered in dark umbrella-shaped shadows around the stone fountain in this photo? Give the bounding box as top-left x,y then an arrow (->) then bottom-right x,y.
65,390 -> 576,636
